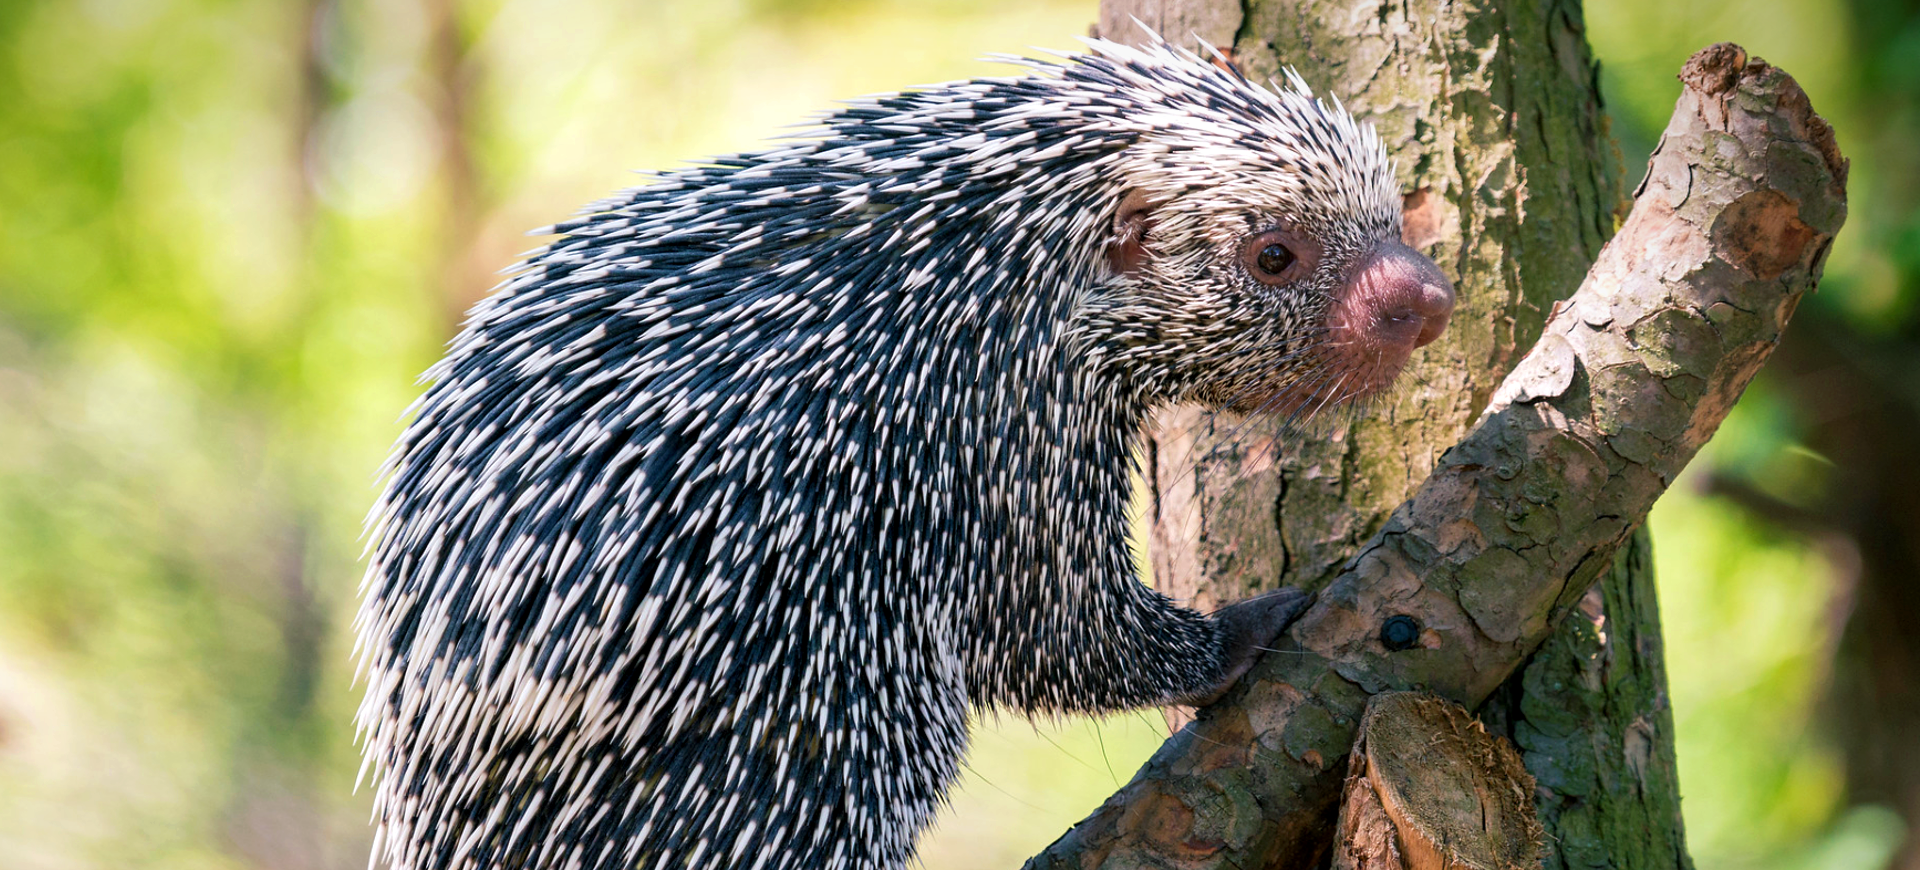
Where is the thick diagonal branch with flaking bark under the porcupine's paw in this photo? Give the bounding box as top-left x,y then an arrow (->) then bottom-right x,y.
1029,46 -> 1845,868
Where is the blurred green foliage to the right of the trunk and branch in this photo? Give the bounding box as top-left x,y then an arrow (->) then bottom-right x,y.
1586,0 -> 1920,870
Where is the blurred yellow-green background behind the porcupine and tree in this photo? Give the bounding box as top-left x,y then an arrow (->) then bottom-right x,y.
0,0 -> 1920,870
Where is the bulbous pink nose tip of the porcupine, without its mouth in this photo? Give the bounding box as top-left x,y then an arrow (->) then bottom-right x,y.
1342,240 -> 1453,351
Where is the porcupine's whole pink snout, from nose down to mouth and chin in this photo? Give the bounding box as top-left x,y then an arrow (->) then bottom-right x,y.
1327,240 -> 1453,396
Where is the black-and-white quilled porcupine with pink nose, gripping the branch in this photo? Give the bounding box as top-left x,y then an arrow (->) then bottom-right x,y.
357,40 -> 1452,870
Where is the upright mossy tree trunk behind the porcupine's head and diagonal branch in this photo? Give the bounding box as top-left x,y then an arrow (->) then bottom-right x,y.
1102,0 -> 1688,868
